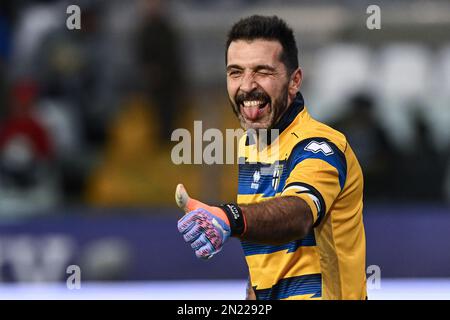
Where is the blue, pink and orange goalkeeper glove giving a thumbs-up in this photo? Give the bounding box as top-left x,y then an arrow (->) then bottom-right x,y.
175,184 -> 246,259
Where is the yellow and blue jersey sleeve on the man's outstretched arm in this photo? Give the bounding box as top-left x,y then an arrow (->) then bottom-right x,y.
281,138 -> 347,227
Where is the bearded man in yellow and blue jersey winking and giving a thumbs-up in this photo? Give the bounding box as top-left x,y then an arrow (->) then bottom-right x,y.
176,16 -> 367,299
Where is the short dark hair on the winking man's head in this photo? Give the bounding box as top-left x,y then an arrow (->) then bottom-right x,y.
225,15 -> 298,73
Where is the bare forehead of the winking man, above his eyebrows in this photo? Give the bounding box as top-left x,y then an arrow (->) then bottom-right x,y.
227,39 -> 282,66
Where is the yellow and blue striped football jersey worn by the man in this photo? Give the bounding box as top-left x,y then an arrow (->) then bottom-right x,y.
237,93 -> 367,299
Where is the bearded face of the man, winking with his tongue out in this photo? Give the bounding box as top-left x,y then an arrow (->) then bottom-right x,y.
227,39 -> 292,130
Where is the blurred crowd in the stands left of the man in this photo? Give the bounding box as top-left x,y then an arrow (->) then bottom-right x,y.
0,0 -> 195,215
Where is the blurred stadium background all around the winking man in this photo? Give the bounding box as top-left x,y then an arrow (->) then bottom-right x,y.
0,0 -> 450,299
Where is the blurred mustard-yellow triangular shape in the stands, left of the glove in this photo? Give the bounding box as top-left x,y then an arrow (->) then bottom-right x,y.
86,93 -> 199,206
